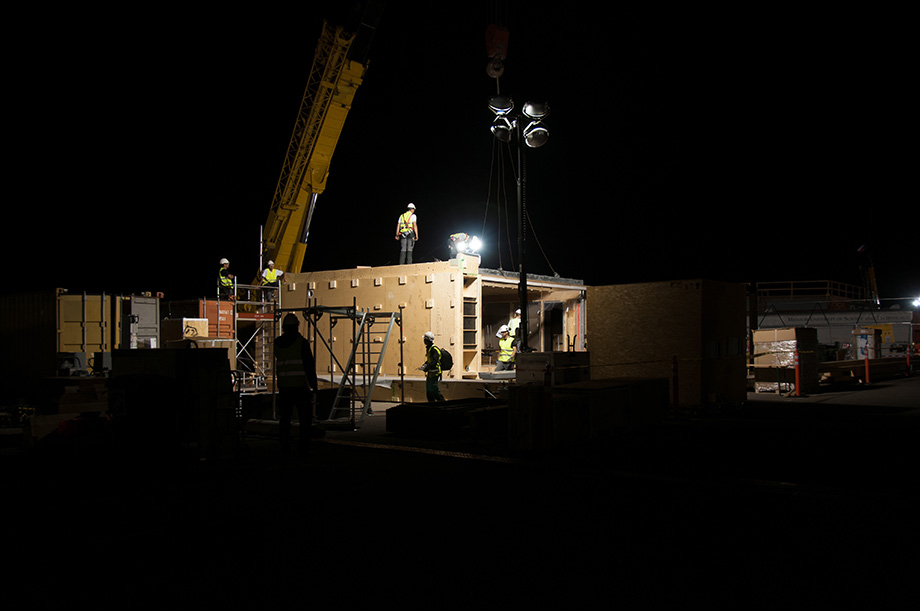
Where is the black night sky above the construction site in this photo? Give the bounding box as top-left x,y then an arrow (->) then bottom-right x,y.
10,2 -> 920,298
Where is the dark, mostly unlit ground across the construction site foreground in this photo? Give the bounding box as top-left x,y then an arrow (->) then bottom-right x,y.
3,376 -> 920,610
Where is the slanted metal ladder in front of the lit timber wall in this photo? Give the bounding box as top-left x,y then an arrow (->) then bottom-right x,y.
329,310 -> 401,422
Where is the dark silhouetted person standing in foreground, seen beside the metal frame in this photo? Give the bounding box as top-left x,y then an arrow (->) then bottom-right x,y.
274,314 -> 317,458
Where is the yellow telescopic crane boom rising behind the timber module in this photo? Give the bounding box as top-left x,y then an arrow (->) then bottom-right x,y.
262,21 -> 366,272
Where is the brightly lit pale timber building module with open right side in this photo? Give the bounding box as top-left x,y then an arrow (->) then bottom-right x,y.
280,255 -> 586,380
